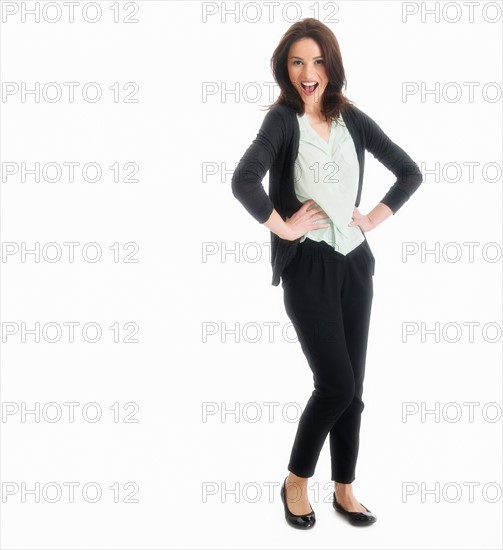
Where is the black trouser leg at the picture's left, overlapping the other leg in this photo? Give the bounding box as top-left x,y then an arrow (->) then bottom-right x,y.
283,239 -> 355,498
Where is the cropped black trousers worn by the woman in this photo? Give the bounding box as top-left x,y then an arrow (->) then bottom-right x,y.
282,238 -> 375,483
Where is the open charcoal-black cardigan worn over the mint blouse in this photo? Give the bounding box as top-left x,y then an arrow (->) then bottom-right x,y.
231,104 -> 423,286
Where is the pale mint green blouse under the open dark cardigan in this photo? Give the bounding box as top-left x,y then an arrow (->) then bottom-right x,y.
294,114 -> 365,255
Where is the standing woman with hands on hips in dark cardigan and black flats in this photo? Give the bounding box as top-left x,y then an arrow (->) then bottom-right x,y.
232,18 -> 423,529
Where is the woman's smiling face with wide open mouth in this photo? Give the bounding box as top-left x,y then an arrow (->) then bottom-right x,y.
287,38 -> 328,107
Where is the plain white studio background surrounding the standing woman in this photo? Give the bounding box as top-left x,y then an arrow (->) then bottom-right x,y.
0,0 -> 502,549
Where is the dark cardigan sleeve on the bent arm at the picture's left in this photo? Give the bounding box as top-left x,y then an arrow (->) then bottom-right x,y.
231,110 -> 286,223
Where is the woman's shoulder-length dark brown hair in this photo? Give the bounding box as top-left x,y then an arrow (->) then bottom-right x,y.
269,17 -> 353,121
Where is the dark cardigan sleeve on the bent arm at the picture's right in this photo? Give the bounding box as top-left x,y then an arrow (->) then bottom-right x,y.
360,106 -> 423,214
